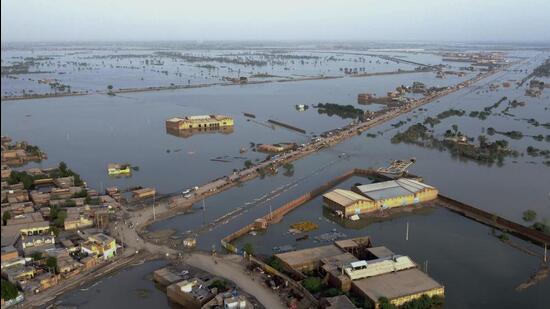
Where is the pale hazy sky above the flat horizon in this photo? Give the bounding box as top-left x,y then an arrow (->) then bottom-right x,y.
1,0 -> 550,42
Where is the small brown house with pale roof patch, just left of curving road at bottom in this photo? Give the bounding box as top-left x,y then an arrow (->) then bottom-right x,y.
166,278 -> 215,309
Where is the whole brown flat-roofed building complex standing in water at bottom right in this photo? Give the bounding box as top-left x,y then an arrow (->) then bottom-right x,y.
275,237 -> 445,308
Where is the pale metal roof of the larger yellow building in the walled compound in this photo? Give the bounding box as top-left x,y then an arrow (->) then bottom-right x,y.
357,178 -> 434,200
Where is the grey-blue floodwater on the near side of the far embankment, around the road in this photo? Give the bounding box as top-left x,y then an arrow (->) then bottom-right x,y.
2,46 -> 550,308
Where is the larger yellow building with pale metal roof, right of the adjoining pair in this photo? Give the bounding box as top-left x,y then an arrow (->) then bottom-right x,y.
352,178 -> 438,209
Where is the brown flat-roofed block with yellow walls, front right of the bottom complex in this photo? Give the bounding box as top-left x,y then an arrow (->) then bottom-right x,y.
352,268 -> 445,308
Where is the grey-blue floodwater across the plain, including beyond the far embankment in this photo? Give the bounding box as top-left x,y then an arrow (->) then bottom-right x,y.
1,47 -> 550,308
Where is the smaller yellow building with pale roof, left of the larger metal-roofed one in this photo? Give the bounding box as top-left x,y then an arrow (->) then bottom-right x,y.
323,189 -> 377,218
